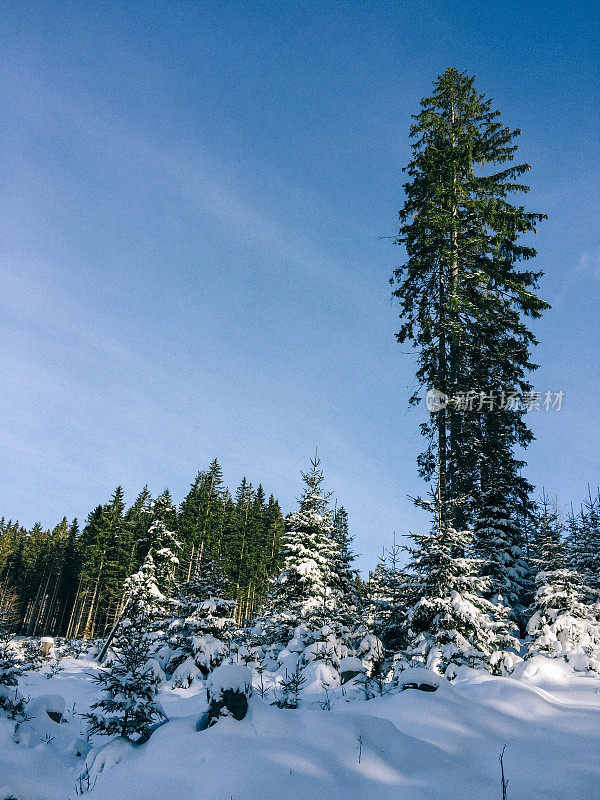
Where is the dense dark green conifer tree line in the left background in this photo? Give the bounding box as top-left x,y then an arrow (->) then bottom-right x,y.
0,459 -> 284,638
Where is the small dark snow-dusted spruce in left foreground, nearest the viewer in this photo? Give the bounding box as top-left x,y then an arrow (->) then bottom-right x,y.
83,604 -> 166,743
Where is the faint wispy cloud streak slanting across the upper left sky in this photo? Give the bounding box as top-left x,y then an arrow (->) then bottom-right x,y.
5,76 -> 353,294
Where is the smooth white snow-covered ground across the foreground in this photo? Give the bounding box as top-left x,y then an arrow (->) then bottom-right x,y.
0,656 -> 600,800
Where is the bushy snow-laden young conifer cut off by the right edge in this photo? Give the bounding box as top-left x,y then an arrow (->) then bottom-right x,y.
528,569 -> 600,672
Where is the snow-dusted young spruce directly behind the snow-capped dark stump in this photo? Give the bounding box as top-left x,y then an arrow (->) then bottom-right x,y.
167,558 -> 237,684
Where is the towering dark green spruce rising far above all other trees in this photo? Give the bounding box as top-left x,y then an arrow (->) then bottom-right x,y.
391,68 -> 548,536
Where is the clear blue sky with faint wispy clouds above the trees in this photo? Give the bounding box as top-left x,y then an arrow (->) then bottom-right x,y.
0,0 -> 600,568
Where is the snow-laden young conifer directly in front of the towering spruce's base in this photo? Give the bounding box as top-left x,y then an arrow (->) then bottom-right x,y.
406,506 -> 518,677
